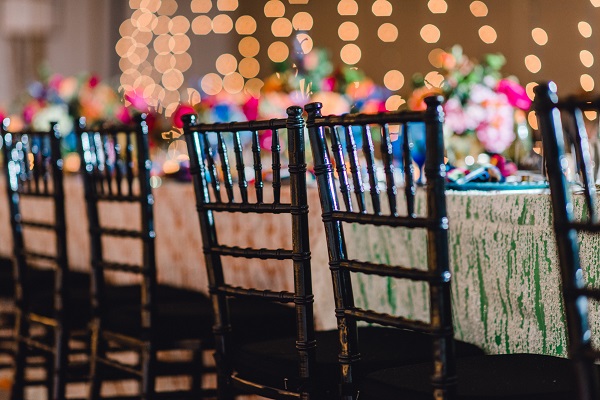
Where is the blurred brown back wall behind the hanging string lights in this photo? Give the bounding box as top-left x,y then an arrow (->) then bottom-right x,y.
0,0 -> 600,104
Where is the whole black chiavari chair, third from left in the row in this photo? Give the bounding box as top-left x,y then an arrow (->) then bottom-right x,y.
184,107 -> 315,399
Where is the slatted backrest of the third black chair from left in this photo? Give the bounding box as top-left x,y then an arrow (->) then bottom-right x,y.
184,107 -> 315,396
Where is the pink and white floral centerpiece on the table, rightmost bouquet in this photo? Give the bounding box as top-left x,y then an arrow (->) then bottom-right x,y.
408,46 -> 531,175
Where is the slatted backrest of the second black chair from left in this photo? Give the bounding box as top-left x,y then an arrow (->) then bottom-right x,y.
77,114 -> 156,340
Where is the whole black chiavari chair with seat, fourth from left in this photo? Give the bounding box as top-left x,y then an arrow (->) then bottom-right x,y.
306,97 -> 580,400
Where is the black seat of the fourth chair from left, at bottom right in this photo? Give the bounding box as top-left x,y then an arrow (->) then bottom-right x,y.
359,354 -> 577,400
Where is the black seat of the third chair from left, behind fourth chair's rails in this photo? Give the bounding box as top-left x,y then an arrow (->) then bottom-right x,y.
234,327 -> 483,393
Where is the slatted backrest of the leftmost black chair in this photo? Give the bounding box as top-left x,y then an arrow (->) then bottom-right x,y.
0,119 -> 69,318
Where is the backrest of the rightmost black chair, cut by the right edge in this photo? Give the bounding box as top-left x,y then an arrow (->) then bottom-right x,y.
533,83 -> 600,399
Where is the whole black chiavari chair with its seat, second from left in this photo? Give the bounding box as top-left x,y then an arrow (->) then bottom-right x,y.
77,115 -> 217,399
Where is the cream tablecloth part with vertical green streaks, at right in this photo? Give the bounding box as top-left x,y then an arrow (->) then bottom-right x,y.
345,190 -> 600,356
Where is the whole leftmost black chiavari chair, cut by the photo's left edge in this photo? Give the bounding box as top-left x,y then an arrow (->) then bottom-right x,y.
2,121 -> 89,400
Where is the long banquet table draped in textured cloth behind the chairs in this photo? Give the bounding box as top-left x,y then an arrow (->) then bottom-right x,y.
0,175 -> 600,356
